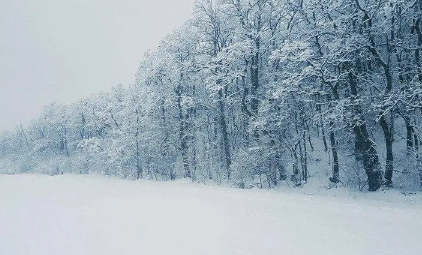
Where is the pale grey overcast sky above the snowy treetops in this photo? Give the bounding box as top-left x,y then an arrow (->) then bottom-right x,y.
0,0 -> 194,131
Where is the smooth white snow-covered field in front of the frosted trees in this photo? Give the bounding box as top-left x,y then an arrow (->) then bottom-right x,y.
0,175 -> 422,255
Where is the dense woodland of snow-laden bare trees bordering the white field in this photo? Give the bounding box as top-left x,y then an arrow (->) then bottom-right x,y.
0,0 -> 422,191
